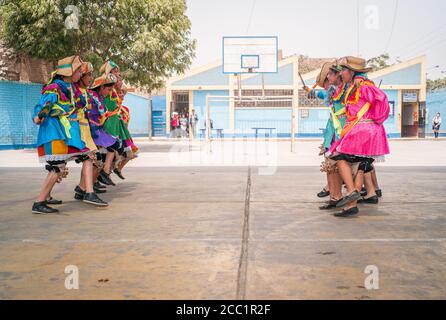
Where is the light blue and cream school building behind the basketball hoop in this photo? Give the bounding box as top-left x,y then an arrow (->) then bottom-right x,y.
152,56 -> 434,138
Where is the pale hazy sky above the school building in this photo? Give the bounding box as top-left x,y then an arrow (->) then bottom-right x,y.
187,0 -> 446,78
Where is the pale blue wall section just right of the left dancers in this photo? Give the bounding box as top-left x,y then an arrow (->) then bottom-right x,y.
123,93 -> 149,137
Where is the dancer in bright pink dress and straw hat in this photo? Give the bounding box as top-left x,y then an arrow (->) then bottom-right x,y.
328,57 -> 390,217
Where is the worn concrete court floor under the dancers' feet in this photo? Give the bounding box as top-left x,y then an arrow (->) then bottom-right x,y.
0,167 -> 446,299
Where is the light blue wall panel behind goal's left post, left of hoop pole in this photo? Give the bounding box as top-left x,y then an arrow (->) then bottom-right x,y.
193,90 -> 229,130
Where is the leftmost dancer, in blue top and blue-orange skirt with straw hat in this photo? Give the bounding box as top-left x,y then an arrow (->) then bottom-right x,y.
32,56 -> 106,214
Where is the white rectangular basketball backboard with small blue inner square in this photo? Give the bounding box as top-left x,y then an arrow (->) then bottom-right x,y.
223,36 -> 279,74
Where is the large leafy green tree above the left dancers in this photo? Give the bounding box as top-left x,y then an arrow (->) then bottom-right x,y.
0,0 -> 195,89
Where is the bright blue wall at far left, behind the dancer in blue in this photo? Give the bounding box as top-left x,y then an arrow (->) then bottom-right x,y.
0,81 -> 42,149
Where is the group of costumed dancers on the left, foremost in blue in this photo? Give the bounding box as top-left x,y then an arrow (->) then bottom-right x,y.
32,56 -> 138,214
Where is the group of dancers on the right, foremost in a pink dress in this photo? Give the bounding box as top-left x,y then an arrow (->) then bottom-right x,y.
304,56 -> 390,217
